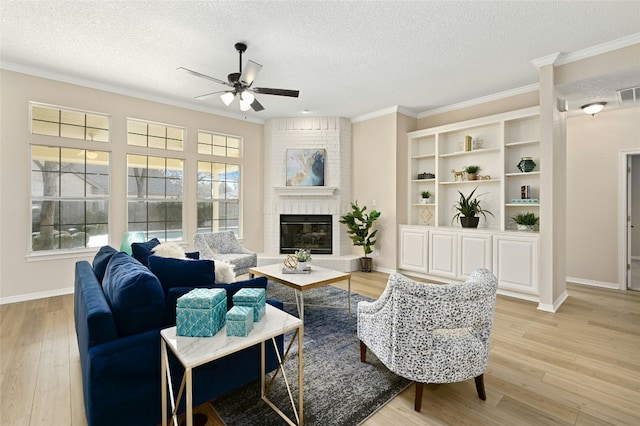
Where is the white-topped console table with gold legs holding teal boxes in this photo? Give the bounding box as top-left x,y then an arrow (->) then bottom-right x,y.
160,304 -> 304,426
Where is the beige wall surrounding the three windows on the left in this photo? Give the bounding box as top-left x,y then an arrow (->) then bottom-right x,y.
0,70 -> 263,303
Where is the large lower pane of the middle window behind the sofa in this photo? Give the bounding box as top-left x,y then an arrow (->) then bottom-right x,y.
127,154 -> 184,241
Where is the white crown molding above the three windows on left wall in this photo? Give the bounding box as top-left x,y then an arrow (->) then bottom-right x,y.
0,61 -> 264,124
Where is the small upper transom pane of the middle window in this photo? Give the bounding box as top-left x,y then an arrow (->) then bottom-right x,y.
127,119 -> 184,151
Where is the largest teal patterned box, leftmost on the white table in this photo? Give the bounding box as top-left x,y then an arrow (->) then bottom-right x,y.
176,288 -> 227,337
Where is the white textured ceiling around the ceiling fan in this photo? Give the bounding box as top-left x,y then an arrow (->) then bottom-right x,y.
0,0 -> 640,120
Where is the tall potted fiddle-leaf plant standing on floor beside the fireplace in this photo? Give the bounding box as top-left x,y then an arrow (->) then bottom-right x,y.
339,200 -> 380,272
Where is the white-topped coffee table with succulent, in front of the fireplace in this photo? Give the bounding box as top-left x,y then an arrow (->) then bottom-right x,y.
249,263 -> 351,321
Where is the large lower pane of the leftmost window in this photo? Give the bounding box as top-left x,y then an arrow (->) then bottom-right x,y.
31,146 -> 109,252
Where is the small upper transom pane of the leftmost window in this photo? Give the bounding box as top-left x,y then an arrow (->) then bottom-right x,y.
31,102 -> 110,142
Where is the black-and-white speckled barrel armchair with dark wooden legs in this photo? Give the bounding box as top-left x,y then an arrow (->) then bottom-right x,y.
358,269 -> 498,411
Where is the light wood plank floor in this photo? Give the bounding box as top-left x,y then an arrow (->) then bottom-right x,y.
0,272 -> 640,426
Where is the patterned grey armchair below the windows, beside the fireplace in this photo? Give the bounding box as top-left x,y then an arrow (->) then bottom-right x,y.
193,231 -> 258,276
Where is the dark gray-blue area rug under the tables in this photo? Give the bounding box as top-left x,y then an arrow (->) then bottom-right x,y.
213,282 -> 411,426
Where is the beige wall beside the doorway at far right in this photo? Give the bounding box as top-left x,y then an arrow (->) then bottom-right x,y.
566,107 -> 640,287
